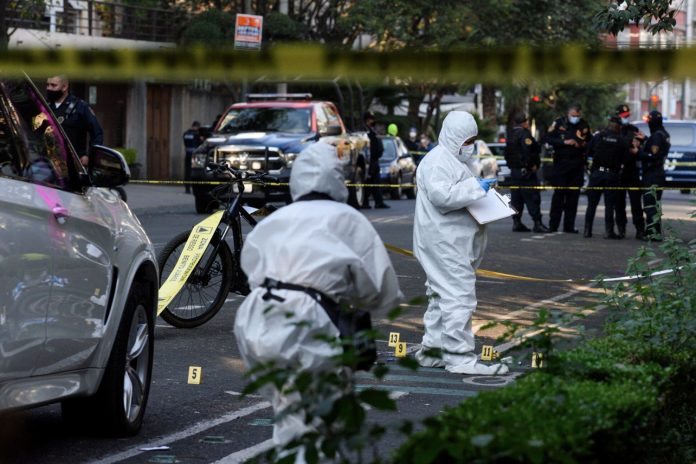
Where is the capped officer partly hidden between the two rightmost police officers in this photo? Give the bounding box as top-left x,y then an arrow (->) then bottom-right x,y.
615,104 -> 646,240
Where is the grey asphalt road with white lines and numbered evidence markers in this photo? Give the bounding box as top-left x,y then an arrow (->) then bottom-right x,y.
0,191 -> 696,463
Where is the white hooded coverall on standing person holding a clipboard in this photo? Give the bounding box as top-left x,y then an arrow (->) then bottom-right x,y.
413,111 -> 507,375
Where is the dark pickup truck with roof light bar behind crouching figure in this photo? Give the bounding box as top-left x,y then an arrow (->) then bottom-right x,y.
191,94 -> 369,213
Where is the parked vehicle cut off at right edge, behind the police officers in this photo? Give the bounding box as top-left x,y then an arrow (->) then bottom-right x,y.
633,121 -> 696,193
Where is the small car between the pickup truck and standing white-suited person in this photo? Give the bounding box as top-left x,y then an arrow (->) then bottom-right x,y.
379,135 -> 416,200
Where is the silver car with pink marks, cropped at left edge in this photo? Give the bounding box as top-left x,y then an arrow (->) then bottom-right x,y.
0,79 -> 159,436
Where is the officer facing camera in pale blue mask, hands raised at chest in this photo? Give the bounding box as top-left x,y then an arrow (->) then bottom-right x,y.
546,104 -> 592,234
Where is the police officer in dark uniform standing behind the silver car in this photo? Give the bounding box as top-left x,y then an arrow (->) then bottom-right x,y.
46,75 -> 104,166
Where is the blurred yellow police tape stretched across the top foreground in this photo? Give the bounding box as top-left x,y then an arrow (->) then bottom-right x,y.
0,44 -> 696,83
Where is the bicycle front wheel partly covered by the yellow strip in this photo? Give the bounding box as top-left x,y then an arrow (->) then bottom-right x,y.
157,230 -> 234,329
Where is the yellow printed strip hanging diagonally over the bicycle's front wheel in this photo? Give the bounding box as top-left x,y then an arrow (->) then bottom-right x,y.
157,210 -> 224,316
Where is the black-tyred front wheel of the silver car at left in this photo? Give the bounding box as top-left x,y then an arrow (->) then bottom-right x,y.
62,282 -> 155,437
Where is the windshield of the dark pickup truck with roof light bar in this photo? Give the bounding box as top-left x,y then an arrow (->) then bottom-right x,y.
217,108 -> 311,134
